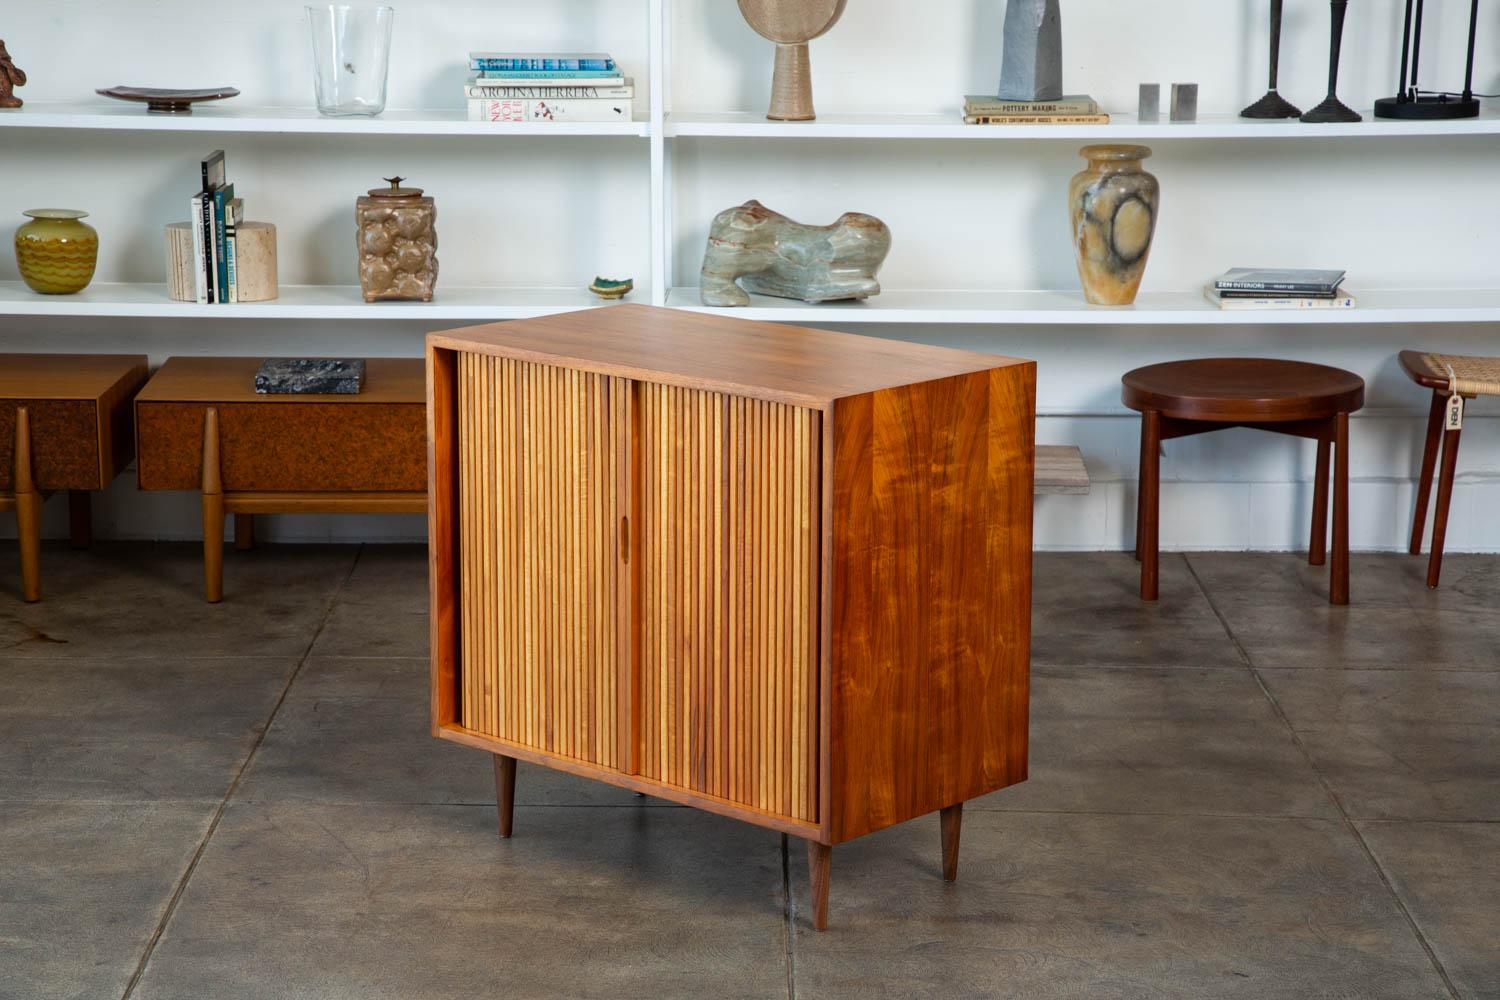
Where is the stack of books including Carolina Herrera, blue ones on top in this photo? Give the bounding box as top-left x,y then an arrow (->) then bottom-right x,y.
464,52 -> 636,124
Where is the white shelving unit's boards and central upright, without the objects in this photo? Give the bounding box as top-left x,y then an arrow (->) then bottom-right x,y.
0,0 -> 1500,325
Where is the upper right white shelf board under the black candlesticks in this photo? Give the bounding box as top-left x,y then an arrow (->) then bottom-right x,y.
665,105 -> 1500,141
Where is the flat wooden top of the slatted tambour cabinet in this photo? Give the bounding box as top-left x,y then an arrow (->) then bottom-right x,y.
428,306 -> 1028,406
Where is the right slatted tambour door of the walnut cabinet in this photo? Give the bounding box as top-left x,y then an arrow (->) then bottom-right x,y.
636,384 -> 822,822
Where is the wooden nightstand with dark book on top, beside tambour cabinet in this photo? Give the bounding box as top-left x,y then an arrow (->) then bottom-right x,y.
135,357 -> 428,603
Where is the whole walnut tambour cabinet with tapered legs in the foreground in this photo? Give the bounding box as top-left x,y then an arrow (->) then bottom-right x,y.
428,306 -> 1037,928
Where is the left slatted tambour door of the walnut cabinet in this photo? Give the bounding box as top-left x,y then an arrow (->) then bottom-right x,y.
458,354 -> 630,768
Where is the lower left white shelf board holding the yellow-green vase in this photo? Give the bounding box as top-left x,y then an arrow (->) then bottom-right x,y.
0,282 -> 621,322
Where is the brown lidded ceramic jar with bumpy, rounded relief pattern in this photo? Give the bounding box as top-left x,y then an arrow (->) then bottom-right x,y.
354,177 -> 438,301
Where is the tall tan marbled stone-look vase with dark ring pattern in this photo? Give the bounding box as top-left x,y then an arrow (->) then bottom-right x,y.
1068,145 -> 1161,306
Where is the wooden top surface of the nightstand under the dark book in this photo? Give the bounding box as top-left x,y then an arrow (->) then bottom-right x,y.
135,357 -> 428,403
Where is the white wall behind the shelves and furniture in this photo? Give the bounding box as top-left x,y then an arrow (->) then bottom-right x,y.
0,0 -> 1500,550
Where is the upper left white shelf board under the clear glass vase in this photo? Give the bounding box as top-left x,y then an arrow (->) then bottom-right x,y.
0,97 -> 651,136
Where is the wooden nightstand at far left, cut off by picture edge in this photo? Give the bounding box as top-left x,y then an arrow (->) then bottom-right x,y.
0,354 -> 147,601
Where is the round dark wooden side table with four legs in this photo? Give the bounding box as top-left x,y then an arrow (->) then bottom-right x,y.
1121,358 -> 1365,604
